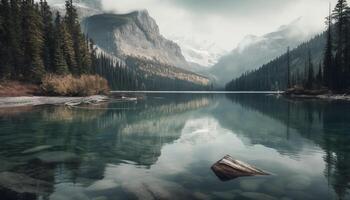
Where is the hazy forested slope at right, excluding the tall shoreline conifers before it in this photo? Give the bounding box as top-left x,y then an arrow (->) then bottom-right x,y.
226,32 -> 326,91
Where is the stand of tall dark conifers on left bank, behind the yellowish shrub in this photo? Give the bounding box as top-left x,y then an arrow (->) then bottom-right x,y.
0,0 -> 93,83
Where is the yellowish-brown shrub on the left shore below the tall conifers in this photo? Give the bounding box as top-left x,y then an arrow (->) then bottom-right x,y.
41,74 -> 109,96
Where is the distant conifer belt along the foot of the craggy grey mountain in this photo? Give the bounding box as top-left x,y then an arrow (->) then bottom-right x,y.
92,53 -> 212,91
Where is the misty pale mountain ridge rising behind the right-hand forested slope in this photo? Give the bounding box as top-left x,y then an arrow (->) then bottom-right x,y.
210,18 -> 320,86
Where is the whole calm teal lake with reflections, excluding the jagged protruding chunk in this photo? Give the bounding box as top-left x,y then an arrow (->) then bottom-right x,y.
0,94 -> 350,200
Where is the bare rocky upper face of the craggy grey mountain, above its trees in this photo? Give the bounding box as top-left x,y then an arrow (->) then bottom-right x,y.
82,10 -> 189,69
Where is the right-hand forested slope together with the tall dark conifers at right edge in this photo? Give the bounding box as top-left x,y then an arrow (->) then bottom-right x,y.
226,0 -> 350,91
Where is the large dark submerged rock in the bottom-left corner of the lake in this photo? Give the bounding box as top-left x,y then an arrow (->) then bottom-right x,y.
0,172 -> 52,194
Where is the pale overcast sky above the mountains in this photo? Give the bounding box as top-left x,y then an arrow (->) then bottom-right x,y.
102,0 -> 336,50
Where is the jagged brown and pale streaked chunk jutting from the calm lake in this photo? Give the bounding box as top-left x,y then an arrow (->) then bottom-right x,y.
211,155 -> 270,181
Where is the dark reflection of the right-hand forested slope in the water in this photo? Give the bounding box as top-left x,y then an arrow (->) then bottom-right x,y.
229,95 -> 350,199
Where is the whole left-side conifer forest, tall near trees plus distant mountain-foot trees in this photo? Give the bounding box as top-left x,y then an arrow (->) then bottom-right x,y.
0,0 -> 208,90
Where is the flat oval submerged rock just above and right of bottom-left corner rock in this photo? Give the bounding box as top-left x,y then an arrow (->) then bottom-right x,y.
37,151 -> 80,163
